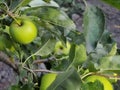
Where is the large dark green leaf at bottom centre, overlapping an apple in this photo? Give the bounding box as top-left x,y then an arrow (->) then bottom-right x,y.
48,69 -> 81,90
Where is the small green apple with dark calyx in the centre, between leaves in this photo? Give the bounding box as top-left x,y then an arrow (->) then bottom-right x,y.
54,41 -> 71,55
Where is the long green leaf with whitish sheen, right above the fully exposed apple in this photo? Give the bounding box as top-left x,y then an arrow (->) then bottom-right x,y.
23,7 -> 76,34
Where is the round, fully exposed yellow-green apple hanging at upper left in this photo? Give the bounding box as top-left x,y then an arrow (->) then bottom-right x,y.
10,18 -> 37,44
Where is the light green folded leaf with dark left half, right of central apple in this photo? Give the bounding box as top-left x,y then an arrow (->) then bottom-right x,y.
68,44 -> 87,69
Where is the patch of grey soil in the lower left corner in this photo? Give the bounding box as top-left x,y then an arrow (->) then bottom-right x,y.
0,51 -> 17,90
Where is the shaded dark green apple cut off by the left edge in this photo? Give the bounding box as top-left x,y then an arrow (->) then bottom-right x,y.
0,34 -> 13,51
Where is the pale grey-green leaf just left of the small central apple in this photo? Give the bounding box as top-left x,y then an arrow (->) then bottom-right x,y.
34,39 -> 56,56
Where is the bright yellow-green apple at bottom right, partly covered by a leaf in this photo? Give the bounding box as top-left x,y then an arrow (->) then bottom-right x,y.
85,75 -> 113,90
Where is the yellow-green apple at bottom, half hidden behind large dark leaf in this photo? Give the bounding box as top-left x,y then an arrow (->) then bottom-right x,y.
40,73 -> 57,90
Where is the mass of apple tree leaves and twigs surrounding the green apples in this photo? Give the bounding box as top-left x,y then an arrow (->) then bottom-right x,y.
0,0 -> 120,90
